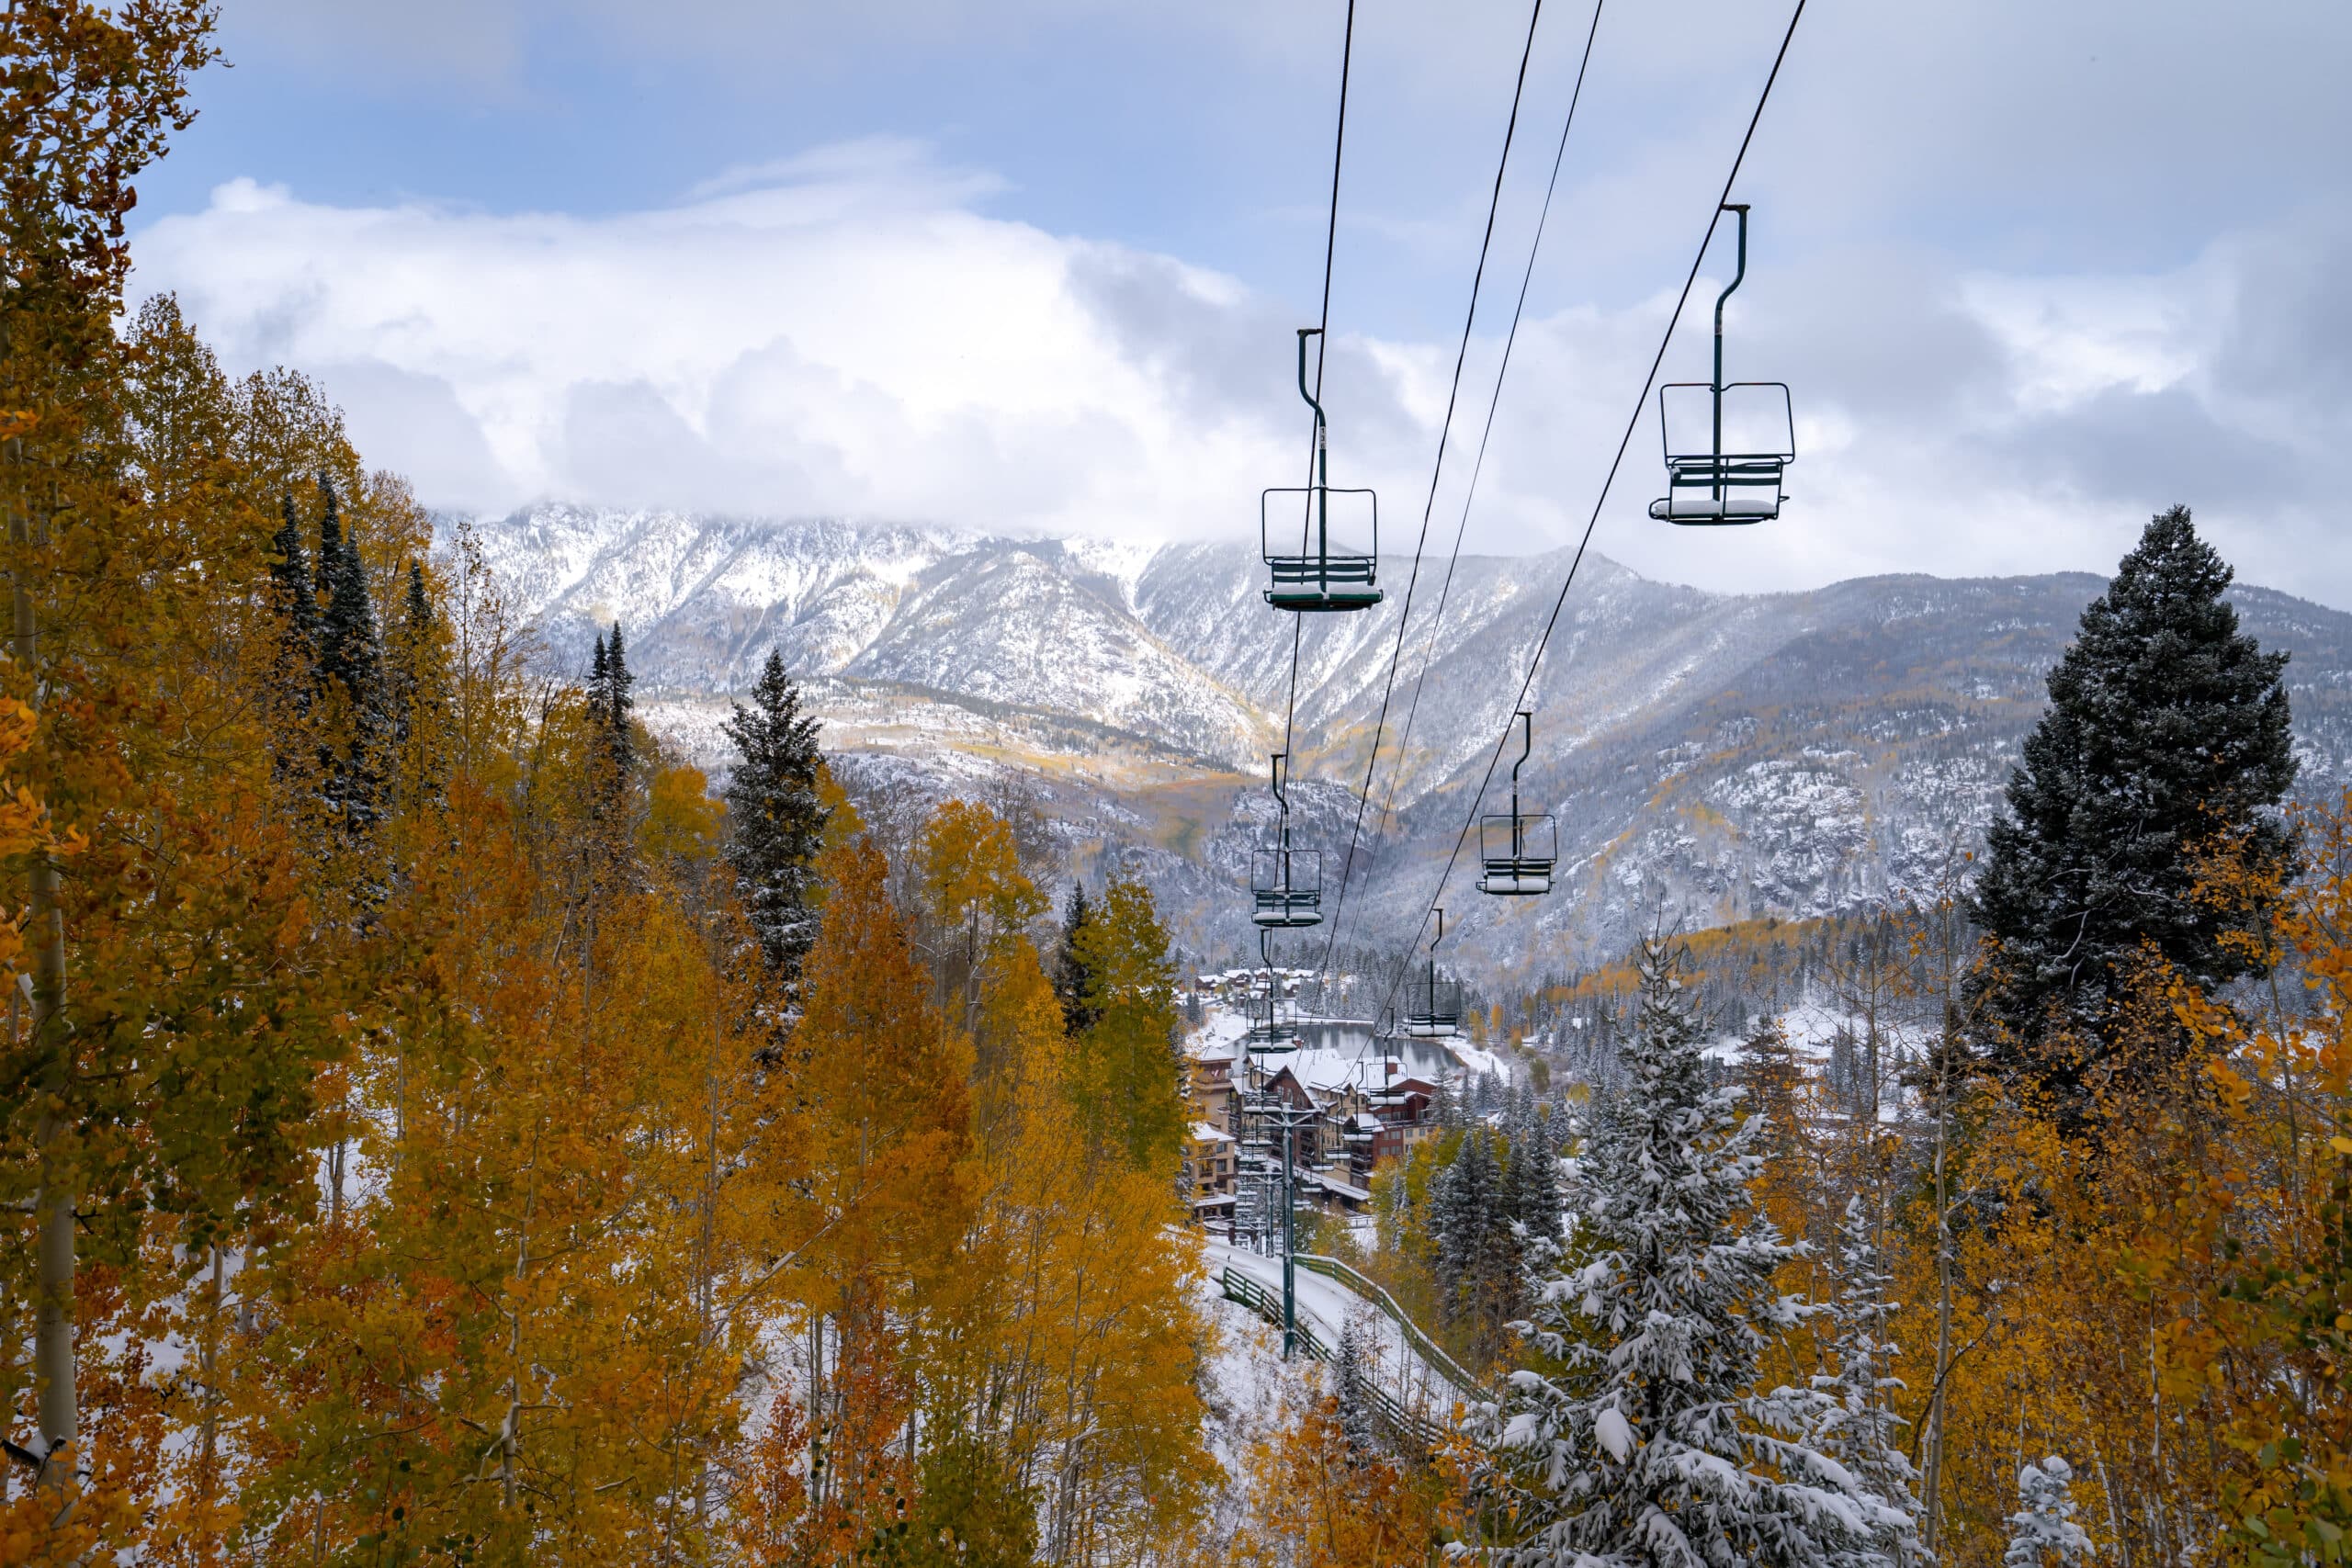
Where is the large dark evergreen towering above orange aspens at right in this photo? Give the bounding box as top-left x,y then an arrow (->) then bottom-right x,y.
1973,505 -> 2296,1100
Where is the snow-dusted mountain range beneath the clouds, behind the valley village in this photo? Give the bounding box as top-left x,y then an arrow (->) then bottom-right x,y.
454,505 -> 2352,964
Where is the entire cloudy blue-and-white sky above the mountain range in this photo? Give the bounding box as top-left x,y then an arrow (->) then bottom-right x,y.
134,0 -> 2352,606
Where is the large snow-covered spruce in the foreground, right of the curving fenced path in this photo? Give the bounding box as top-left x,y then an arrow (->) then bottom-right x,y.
1477,938 -> 1903,1568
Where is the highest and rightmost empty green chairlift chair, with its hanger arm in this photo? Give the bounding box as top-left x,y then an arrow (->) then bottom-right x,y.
1649,202 -> 1797,526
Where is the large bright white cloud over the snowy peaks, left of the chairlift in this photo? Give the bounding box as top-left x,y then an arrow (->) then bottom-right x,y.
139,146 -> 1326,534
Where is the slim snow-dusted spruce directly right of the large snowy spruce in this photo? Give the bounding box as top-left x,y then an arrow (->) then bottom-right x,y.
1814,1197 -> 1924,1568
